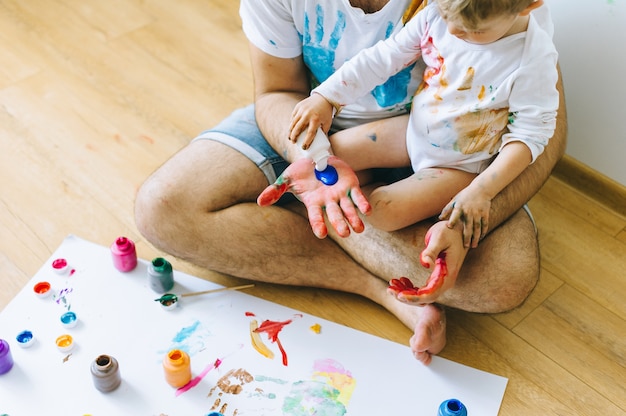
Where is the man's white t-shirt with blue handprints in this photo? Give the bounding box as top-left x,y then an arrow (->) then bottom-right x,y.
240,0 -> 424,128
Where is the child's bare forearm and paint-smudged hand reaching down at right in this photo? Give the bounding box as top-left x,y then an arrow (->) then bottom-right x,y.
439,141 -> 532,247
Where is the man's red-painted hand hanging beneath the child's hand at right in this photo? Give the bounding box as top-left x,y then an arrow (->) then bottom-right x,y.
387,221 -> 468,306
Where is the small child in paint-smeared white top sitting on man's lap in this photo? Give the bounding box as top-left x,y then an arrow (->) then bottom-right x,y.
290,0 -> 559,247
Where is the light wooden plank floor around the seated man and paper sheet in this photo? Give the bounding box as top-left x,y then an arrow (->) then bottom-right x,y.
0,0 -> 626,416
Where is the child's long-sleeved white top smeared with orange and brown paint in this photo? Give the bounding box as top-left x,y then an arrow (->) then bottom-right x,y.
314,2 -> 559,173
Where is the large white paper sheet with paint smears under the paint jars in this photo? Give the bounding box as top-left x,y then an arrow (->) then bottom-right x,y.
0,236 -> 507,416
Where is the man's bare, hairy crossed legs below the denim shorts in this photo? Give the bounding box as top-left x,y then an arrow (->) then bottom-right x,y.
136,140 -> 538,362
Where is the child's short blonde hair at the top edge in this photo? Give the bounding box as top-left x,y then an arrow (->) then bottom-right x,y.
437,0 -> 535,28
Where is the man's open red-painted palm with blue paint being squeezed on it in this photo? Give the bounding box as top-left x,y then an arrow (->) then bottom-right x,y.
257,156 -> 372,238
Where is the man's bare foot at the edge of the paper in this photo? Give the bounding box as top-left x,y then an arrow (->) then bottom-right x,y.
409,304 -> 446,365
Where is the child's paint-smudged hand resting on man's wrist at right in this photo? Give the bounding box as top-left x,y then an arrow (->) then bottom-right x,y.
439,187 -> 491,248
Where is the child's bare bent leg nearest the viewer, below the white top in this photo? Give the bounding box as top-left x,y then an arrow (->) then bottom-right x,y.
365,168 -> 476,231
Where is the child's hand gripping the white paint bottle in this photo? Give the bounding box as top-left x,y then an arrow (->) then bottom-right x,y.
289,94 -> 333,150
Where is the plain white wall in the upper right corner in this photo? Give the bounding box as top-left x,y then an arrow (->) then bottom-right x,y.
544,0 -> 626,186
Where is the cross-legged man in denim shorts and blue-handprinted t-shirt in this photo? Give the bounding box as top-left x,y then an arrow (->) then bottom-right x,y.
136,0 -> 566,364
